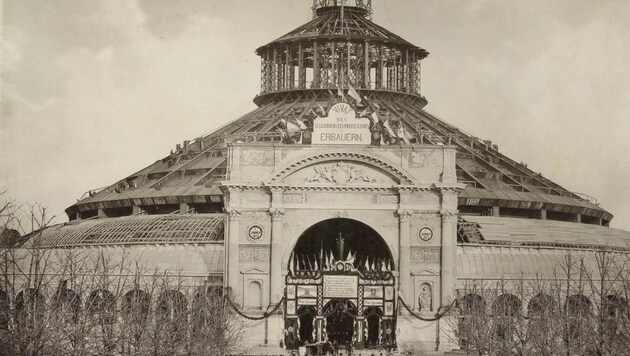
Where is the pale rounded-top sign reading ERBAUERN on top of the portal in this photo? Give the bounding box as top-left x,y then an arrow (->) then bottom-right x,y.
313,103 -> 371,145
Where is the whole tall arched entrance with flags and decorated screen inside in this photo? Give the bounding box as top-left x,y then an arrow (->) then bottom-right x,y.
285,218 -> 396,351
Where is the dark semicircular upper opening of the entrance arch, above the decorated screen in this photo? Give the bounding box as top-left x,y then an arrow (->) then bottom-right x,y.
289,218 -> 394,271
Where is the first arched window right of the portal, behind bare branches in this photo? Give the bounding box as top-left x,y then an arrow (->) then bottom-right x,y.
458,293 -> 488,349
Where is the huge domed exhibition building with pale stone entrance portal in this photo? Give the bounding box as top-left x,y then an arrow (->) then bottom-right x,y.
18,0 -> 630,352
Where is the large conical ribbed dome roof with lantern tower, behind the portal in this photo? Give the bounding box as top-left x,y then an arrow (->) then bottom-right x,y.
66,1 -> 612,225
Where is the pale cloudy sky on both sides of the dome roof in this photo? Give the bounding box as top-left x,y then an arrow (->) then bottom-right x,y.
0,0 -> 630,230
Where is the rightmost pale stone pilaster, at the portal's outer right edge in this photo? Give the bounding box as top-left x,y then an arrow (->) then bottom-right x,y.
440,189 -> 459,307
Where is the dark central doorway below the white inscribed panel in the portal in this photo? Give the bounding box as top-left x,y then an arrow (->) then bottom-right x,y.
324,299 -> 357,346
